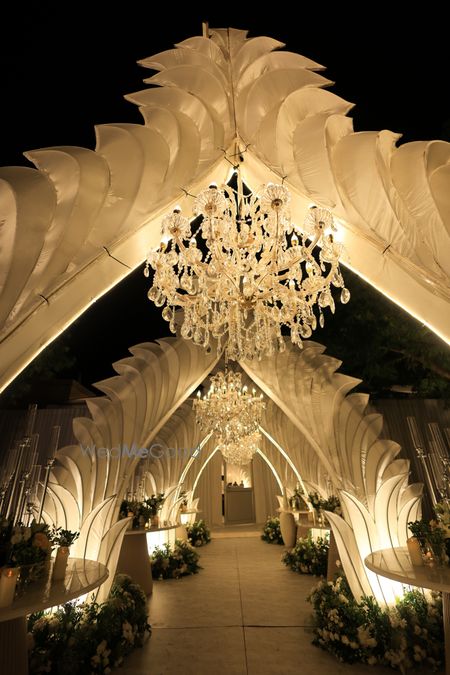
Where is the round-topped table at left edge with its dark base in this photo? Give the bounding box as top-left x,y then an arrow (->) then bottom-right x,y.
0,558 -> 108,675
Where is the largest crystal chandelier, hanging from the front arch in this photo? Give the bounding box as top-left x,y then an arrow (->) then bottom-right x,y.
144,174 -> 350,360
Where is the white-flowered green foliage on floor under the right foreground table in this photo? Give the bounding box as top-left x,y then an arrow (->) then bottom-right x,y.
308,576 -> 444,673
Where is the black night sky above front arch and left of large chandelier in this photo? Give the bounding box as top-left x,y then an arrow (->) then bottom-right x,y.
0,2 -> 450,384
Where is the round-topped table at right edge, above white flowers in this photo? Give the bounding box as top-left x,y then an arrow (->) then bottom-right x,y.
364,546 -> 450,675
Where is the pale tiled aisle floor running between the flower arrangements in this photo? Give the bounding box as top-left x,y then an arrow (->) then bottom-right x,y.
120,531 -> 393,675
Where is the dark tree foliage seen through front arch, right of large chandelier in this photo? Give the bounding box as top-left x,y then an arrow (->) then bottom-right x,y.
313,269 -> 450,398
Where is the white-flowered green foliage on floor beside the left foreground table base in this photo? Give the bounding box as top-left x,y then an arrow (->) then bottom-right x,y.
28,575 -> 150,675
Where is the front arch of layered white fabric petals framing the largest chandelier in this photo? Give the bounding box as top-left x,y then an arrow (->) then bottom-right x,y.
0,29 -> 450,388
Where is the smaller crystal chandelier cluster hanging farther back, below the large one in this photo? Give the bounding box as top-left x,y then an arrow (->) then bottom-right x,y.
193,371 -> 266,464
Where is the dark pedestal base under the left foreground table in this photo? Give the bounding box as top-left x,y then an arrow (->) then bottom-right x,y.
0,616 -> 28,675
